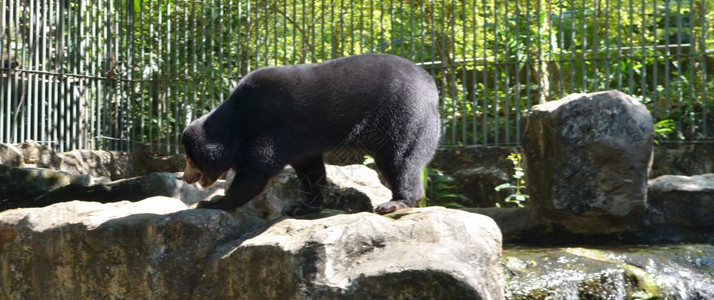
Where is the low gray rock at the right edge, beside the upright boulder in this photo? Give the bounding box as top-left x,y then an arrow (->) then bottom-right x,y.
646,174 -> 714,228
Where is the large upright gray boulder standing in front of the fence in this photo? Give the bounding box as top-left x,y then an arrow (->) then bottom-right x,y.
523,91 -> 654,233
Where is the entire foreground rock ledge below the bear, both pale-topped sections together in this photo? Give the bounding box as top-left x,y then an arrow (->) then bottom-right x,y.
0,197 -> 505,299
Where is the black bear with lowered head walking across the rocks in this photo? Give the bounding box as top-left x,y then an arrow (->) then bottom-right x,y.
183,54 -> 440,215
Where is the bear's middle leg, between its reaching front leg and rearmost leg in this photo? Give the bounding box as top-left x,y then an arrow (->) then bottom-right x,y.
283,154 -> 327,216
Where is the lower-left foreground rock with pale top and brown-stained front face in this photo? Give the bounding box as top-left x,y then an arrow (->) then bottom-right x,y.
0,197 -> 264,299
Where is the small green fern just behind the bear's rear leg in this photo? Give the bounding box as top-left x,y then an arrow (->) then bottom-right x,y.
419,167 -> 467,208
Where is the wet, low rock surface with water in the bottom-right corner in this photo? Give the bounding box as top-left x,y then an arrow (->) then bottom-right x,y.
503,244 -> 714,300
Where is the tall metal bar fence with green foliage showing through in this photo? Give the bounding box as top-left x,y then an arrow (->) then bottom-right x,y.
0,0 -> 714,153
